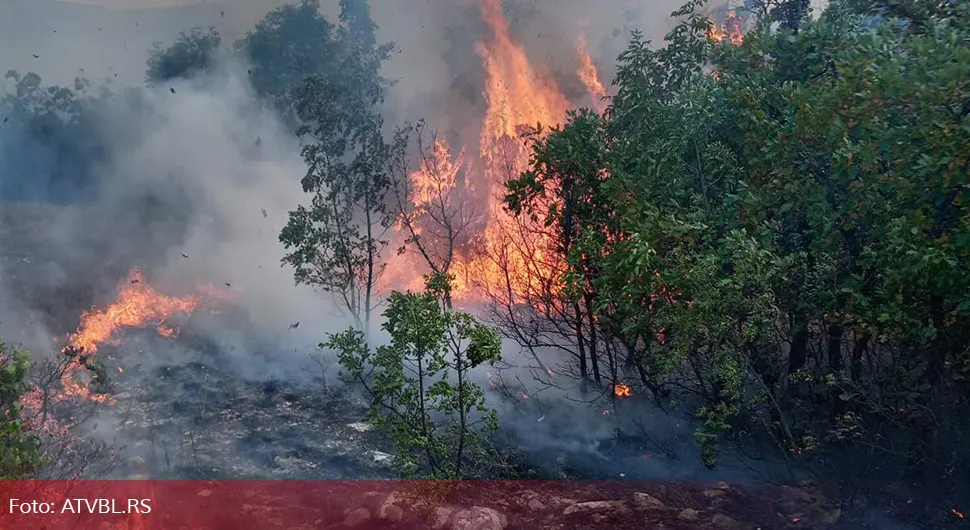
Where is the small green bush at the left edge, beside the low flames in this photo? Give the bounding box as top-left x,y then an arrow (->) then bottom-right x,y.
0,341 -> 45,480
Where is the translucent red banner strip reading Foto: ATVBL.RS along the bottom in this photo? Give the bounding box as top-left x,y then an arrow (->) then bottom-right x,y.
0,481 -> 788,530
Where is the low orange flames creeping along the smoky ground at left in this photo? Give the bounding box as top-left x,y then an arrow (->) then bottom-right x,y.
61,269 -> 225,402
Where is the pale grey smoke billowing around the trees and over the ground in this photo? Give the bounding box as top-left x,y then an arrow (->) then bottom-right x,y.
0,0 -> 699,476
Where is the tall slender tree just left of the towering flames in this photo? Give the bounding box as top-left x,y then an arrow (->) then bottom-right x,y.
280,2 -> 394,330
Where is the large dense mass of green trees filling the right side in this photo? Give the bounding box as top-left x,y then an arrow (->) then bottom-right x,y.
506,0 -> 970,500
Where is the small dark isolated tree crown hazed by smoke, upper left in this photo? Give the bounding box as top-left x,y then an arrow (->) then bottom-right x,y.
145,27 -> 222,85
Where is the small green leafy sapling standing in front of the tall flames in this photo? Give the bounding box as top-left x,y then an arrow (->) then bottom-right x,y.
321,281 -> 501,480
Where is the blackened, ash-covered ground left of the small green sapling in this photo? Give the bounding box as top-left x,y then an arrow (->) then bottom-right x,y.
92,331 -> 394,479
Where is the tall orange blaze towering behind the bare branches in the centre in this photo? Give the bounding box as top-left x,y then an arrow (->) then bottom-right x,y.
382,0 -> 606,304
